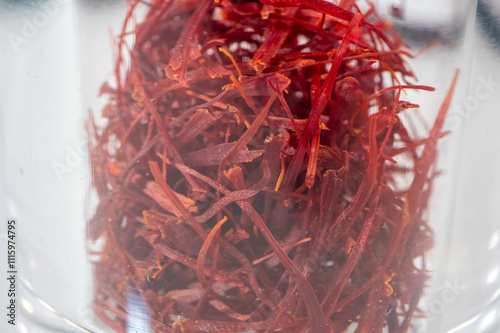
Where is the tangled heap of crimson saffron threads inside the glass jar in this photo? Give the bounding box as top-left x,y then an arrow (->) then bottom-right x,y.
88,0 -> 457,333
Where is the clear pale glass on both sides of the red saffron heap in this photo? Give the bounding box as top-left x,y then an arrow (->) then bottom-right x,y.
0,0 -> 500,333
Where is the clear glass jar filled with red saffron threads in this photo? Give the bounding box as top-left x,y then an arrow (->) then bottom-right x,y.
0,0 -> 500,333
